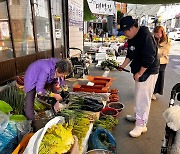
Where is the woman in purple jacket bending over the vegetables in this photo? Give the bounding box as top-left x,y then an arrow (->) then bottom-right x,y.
24,58 -> 72,121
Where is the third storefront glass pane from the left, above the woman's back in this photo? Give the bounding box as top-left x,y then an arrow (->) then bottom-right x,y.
34,0 -> 52,52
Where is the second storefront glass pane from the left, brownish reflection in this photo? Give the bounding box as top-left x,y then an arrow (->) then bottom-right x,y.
9,0 -> 35,57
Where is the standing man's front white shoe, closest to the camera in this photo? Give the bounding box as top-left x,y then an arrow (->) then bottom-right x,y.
129,126 -> 147,137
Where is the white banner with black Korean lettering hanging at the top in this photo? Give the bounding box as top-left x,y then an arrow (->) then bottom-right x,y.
87,0 -> 116,15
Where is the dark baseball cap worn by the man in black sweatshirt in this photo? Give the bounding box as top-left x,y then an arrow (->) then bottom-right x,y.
120,16 -> 136,32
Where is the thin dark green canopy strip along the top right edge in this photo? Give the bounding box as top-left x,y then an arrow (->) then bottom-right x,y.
114,0 -> 180,4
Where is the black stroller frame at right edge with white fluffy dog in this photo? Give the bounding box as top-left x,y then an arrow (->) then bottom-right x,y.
161,83 -> 180,154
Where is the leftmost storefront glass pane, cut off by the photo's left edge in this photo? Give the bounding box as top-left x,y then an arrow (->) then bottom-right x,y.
0,2 -> 13,61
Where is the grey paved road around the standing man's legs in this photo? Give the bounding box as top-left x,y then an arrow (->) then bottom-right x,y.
83,41 -> 180,154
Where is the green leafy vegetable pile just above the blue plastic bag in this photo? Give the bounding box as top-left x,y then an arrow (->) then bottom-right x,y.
94,115 -> 118,131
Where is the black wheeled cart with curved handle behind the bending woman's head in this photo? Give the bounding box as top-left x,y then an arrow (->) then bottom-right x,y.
68,48 -> 89,78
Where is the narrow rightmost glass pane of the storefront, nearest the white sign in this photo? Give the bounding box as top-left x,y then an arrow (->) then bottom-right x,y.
51,0 -> 63,48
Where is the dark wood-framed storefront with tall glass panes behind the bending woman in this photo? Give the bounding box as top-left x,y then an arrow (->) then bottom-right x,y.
0,0 -> 69,84
